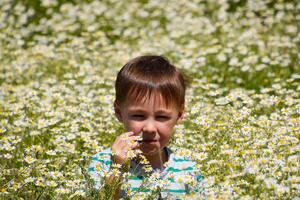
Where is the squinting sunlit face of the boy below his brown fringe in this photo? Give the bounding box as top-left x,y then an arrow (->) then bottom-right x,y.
114,94 -> 183,155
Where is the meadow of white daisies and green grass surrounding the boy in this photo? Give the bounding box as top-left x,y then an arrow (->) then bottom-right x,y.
0,0 -> 300,200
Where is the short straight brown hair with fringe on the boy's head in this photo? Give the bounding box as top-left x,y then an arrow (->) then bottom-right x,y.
115,55 -> 190,108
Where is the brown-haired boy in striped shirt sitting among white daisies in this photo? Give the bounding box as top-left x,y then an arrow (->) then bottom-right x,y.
89,55 -> 203,199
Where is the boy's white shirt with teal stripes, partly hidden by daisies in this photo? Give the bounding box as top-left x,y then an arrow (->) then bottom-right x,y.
88,147 -> 204,199
